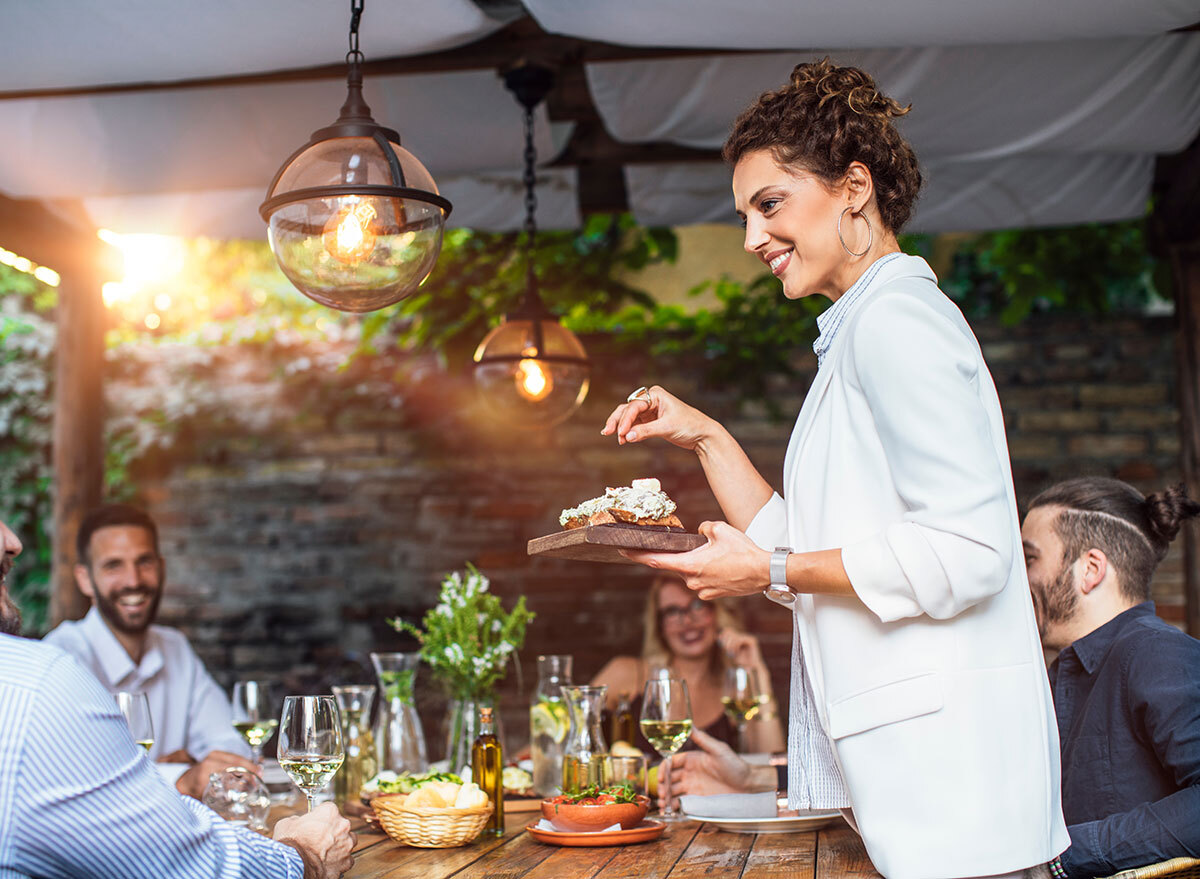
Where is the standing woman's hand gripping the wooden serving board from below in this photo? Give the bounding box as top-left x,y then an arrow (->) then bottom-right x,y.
622,522 -> 770,602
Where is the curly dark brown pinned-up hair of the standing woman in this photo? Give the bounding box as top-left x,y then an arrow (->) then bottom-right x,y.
721,58 -> 922,232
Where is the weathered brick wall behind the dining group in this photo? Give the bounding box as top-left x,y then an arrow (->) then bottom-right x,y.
110,309 -> 1182,753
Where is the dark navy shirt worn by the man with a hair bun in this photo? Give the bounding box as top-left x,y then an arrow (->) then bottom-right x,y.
1050,602 -> 1200,879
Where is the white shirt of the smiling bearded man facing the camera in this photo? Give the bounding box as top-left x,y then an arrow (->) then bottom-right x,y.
44,606 -> 250,760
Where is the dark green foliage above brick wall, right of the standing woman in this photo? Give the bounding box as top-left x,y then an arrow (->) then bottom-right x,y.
942,220 -> 1166,325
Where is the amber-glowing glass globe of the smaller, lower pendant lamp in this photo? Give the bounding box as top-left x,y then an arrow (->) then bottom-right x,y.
475,316 -> 592,429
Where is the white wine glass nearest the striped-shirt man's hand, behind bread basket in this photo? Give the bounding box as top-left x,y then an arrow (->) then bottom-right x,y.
278,696 -> 346,812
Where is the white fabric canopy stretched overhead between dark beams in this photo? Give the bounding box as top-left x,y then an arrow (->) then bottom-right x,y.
0,0 -> 1200,236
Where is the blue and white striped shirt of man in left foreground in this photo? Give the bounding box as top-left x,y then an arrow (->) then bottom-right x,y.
0,635 -> 304,879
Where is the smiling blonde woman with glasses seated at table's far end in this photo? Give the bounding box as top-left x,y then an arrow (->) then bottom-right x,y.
592,575 -> 785,754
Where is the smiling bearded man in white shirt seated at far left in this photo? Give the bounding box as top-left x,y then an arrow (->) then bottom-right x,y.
44,504 -> 251,797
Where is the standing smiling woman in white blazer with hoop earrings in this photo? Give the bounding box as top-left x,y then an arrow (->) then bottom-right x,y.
602,60 -> 1069,879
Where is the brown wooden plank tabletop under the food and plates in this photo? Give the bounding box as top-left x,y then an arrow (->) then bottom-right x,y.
346,813 -> 880,879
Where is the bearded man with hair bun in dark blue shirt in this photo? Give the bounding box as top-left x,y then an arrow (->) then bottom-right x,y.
1021,477 -> 1200,879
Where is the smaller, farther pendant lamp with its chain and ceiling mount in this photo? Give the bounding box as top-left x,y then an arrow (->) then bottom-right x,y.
475,65 -> 592,427
